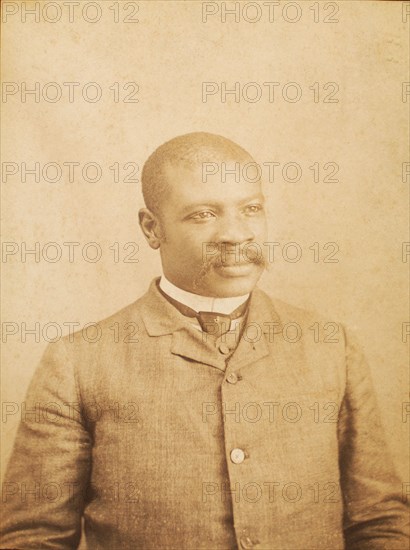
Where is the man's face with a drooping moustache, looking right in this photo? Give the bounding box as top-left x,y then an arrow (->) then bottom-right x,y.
155,160 -> 267,297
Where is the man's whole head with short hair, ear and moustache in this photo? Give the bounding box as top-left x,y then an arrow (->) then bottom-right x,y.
139,132 -> 266,297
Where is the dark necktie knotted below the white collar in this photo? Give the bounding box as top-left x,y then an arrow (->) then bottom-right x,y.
158,286 -> 249,337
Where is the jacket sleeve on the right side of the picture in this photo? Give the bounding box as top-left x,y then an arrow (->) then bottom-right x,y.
339,333 -> 410,550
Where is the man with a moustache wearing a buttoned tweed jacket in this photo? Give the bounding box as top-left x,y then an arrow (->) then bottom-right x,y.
1,133 -> 409,550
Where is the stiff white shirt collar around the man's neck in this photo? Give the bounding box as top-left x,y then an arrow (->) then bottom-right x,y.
159,275 -> 249,314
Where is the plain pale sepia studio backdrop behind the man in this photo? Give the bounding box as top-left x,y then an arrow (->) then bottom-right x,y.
2,1 -> 409,484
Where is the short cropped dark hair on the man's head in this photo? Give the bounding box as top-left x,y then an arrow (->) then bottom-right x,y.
141,132 -> 253,213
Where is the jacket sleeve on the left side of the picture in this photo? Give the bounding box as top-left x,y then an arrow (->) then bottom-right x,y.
0,340 -> 91,550
